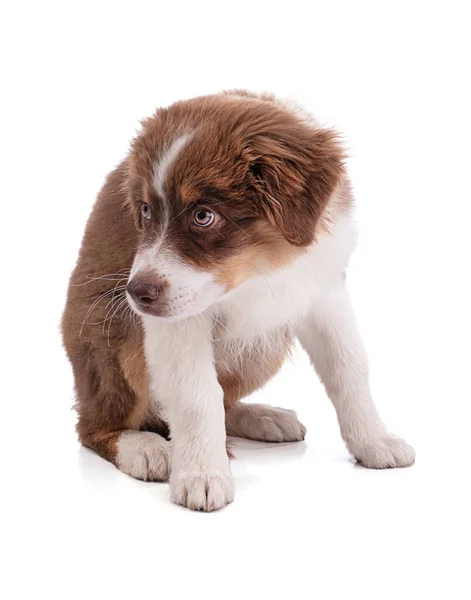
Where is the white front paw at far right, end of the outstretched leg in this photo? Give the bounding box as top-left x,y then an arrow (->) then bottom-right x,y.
347,434 -> 415,469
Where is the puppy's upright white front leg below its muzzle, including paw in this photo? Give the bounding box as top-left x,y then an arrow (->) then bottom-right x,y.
144,316 -> 234,511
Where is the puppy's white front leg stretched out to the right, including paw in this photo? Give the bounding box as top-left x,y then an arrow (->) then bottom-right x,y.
298,277 -> 415,469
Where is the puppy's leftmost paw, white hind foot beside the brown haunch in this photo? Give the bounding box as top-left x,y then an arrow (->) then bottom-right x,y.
116,431 -> 171,481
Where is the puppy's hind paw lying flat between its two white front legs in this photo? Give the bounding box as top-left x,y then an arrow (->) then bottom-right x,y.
226,402 -> 306,442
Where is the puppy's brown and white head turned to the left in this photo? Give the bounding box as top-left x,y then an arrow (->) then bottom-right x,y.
127,95 -> 343,318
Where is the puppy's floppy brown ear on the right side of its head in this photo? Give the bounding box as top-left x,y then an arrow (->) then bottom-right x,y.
246,123 -> 345,246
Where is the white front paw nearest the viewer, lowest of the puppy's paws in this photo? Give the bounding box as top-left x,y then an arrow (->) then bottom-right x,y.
170,472 -> 234,512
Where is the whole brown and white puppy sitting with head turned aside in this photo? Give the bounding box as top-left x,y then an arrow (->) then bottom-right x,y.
62,91 -> 414,511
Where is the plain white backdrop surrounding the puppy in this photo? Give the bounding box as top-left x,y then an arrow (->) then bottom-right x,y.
0,0 -> 471,600
